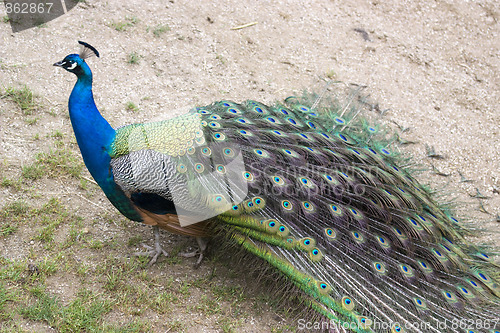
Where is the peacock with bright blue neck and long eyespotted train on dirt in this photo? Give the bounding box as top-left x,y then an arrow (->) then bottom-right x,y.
54,42 -> 500,332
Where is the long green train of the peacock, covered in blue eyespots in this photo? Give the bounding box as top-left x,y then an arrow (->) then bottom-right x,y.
190,92 -> 499,332
